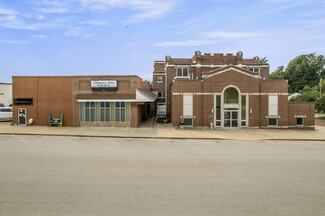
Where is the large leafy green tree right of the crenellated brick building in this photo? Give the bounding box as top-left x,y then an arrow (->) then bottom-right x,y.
284,53 -> 325,92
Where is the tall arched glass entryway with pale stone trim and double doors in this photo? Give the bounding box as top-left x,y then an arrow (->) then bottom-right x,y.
215,85 -> 248,128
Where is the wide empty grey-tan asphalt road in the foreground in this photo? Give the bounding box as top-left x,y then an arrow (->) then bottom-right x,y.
0,136 -> 325,216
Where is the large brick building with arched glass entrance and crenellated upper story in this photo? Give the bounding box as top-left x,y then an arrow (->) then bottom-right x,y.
153,51 -> 314,129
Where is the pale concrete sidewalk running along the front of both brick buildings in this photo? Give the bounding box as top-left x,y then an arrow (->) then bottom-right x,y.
0,122 -> 325,141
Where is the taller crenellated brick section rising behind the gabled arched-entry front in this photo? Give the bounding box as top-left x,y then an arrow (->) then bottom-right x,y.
152,51 -> 269,115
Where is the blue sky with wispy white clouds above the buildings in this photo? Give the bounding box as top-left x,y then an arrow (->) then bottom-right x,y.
0,0 -> 325,83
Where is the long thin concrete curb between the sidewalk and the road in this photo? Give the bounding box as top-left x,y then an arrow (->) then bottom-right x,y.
0,133 -> 325,142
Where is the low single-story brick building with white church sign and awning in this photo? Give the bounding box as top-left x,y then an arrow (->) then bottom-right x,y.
12,76 -> 156,127
